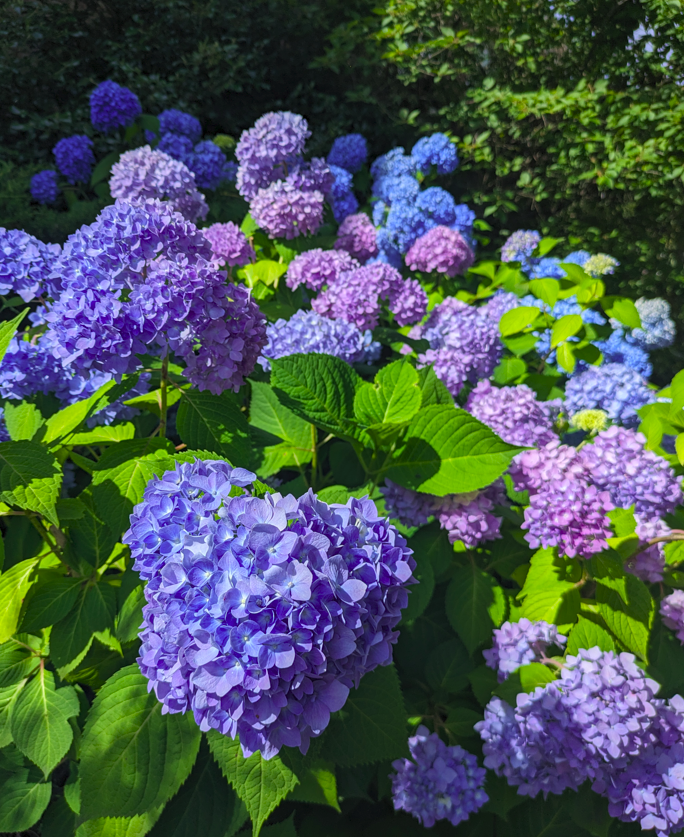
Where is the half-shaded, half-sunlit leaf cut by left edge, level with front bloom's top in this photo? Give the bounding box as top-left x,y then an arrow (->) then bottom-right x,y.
0,442 -> 62,526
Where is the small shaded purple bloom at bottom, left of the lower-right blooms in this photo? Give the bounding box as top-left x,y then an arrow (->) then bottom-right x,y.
390,725 -> 489,828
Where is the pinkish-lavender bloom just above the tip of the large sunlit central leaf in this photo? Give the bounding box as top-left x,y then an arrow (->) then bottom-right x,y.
466,381 -> 559,447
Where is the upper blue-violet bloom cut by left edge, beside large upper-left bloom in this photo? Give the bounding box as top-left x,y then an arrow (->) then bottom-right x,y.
0,227 -> 62,302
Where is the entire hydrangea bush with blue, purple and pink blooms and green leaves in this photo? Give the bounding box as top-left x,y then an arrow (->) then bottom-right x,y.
0,86 -> 684,837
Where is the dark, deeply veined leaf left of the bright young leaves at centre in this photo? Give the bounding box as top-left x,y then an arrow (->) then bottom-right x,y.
271,354 -> 361,435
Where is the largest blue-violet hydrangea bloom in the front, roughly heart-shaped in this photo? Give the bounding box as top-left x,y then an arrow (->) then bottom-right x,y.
123,461 -> 415,759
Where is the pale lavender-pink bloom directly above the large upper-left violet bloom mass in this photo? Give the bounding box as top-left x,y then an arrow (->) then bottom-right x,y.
109,145 -> 209,223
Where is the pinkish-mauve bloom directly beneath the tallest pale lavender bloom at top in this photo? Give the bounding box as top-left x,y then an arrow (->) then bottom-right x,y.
249,181 -> 323,239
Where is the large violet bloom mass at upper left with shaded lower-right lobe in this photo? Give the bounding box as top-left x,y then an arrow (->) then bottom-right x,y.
46,201 -> 266,394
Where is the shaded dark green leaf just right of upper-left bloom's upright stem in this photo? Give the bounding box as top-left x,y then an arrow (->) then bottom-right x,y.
176,389 -> 252,466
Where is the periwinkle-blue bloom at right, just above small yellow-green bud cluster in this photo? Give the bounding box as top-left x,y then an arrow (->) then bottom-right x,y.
565,363 -> 656,427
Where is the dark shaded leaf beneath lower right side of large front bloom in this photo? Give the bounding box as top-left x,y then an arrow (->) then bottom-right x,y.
321,665 -> 407,767
